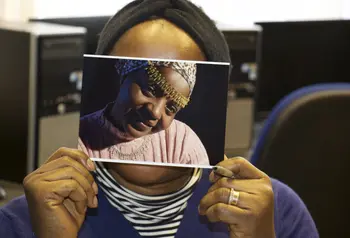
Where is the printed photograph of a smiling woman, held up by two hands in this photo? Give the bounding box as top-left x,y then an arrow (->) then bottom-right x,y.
78,55 -> 230,168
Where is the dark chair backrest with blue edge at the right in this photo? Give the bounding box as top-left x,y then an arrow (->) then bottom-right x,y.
251,83 -> 350,238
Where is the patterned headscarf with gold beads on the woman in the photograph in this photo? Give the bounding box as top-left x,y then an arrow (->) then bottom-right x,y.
115,59 -> 197,108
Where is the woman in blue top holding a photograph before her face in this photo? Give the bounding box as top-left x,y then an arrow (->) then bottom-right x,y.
0,0 -> 318,238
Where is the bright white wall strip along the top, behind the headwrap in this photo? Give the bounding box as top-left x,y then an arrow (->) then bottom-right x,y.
0,0 -> 350,25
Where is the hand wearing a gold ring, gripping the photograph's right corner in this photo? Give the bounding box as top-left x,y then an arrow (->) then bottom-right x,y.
199,158 -> 275,238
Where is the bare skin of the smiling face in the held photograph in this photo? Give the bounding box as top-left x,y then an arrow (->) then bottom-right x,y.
116,68 -> 190,138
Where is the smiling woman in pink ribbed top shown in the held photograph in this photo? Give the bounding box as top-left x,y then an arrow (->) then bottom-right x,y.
79,59 -> 209,165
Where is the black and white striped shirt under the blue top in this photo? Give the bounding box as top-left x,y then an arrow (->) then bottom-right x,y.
96,163 -> 202,238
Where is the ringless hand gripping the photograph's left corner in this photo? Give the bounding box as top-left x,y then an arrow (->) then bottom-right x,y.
23,148 -> 98,238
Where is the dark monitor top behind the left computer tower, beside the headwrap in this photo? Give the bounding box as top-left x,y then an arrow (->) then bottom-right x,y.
30,16 -> 111,54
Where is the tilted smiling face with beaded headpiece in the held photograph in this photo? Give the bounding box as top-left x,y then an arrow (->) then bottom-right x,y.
113,60 -> 196,138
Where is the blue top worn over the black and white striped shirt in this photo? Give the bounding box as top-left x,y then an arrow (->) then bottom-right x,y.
0,173 -> 319,238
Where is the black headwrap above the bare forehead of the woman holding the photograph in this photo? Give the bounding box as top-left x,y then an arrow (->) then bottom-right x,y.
96,0 -> 231,62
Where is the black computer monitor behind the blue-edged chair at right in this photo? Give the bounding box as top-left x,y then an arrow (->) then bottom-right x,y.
255,20 -> 350,120
